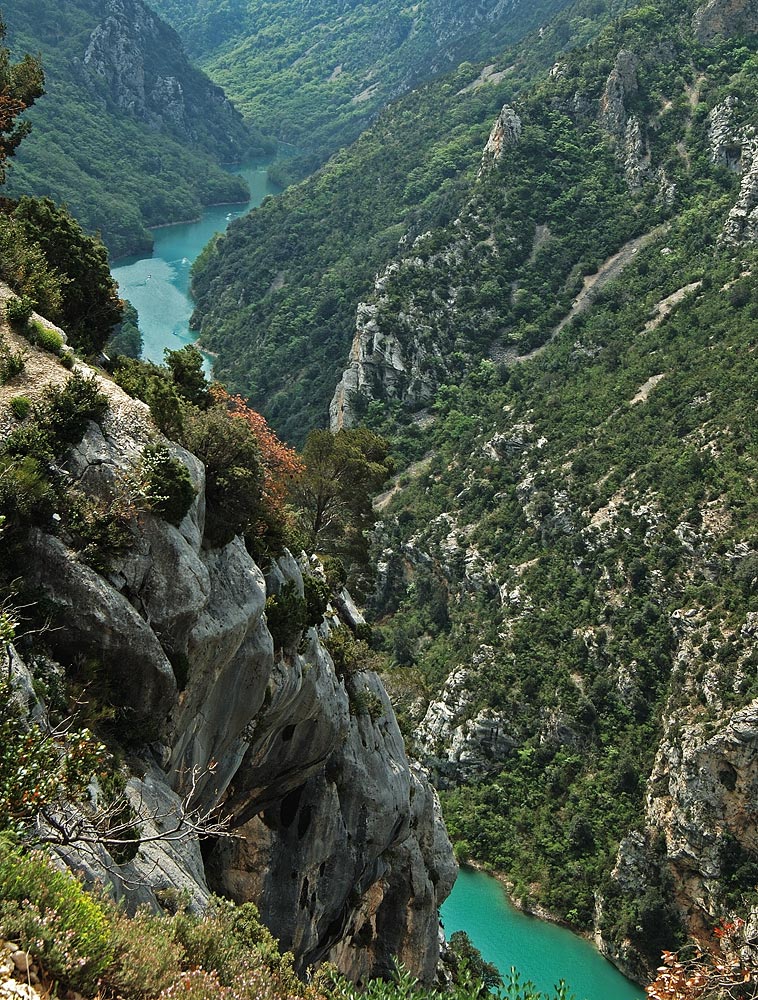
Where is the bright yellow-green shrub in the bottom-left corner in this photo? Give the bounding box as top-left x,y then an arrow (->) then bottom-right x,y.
0,840 -> 113,990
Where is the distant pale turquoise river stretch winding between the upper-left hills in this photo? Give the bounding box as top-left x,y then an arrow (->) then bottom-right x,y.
111,160 -> 279,364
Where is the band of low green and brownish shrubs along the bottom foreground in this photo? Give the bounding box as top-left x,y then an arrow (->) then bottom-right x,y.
0,838 -> 571,1000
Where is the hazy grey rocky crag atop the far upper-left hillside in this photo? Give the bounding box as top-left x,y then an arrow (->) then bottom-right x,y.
80,0 -> 245,159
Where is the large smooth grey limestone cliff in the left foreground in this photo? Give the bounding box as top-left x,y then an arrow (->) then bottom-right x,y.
16,366 -> 456,979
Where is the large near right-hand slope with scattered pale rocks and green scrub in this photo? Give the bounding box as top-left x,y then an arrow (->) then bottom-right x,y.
334,5 -> 758,976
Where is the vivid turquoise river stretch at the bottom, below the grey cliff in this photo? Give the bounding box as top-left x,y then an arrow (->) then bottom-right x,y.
441,869 -> 645,1000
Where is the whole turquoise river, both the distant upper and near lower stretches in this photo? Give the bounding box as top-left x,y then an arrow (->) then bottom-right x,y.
113,162 -> 644,1000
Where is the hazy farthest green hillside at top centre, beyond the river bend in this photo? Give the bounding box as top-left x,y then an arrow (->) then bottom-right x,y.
145,0 -> 580,179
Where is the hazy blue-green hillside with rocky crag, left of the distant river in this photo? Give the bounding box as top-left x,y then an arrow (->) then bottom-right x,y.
2,0 -> 270,254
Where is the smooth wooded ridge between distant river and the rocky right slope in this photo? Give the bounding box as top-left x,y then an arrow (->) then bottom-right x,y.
193,2 -> 636,441
